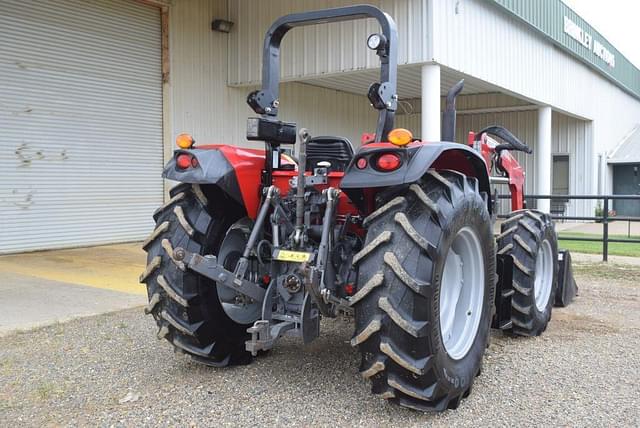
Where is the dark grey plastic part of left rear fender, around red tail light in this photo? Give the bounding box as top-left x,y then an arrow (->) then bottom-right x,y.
162,149 -> 244,206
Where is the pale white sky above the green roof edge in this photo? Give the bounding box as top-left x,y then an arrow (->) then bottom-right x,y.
562,0 -> 640,68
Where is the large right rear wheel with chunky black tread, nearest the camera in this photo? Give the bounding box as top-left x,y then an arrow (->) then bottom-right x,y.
351,170 -> 496,411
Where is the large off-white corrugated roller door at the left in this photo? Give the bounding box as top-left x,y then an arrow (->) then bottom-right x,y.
0,0 -> 163,253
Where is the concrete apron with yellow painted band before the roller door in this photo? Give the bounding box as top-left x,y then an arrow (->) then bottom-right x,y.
0,243 -> 146,336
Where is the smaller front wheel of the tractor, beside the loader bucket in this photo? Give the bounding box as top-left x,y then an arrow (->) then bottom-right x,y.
497,210 -> 558,336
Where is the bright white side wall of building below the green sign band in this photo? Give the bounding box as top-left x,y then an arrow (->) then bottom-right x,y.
430,0 -> 640,181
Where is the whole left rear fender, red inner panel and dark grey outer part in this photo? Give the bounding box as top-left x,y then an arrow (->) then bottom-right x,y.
162,145 -> 265,218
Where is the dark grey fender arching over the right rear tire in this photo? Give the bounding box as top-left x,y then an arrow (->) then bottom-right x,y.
340,142 -> 492,213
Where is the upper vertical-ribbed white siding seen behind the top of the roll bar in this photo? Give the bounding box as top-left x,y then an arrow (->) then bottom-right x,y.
229,0 -> 428,85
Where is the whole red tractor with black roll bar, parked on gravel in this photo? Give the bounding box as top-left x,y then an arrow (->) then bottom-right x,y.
140,5 -> 569,411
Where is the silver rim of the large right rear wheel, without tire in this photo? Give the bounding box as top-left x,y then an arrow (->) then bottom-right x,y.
440,227 -> 485,360
